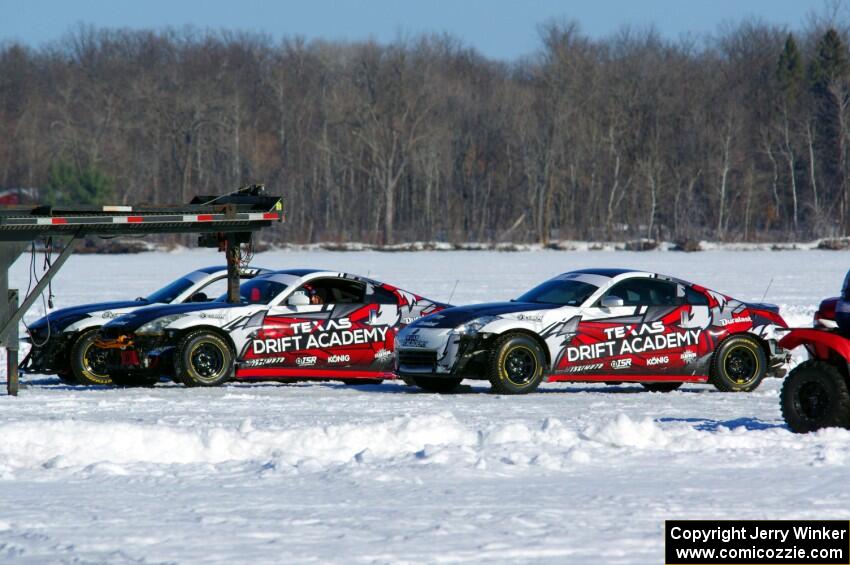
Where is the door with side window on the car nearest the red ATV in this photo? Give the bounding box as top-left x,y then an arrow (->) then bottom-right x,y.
562,277 -> 708,375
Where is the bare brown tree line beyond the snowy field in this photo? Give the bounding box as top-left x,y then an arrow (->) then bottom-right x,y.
0,17 -> 850,243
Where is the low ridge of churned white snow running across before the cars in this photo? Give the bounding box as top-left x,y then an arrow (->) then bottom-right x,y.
0,412 -> 850,478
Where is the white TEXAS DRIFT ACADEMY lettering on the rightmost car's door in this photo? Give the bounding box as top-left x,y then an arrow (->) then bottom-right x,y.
567,321 -> 702,363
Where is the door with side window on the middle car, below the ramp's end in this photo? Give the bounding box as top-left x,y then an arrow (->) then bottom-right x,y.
242,276 -> 398,376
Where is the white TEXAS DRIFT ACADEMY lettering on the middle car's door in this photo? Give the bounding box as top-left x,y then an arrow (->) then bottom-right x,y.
251,318 -> 389,355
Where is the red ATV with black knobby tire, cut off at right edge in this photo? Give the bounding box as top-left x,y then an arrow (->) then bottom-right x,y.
779,282 -> 850,433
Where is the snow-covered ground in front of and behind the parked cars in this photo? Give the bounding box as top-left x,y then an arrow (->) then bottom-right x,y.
0,251 -> 850,563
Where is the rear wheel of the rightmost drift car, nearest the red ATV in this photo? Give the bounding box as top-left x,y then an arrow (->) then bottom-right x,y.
709,335 -> 767,392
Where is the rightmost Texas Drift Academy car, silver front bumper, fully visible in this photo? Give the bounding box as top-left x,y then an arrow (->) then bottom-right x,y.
396,269 -> 787,394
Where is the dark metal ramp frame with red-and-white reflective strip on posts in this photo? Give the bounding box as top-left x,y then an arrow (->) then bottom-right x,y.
0,185 -> 284,396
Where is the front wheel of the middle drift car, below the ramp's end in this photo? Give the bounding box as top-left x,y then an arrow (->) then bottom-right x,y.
175,330 -> 234,386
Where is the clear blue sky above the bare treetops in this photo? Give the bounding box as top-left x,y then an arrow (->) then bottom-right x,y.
0,0 -> 824,59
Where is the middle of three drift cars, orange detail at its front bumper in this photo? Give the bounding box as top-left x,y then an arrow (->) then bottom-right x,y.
97,269 -> 448,386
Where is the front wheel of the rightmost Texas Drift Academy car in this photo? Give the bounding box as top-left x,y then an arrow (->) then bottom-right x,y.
487,333 -> 546,394
